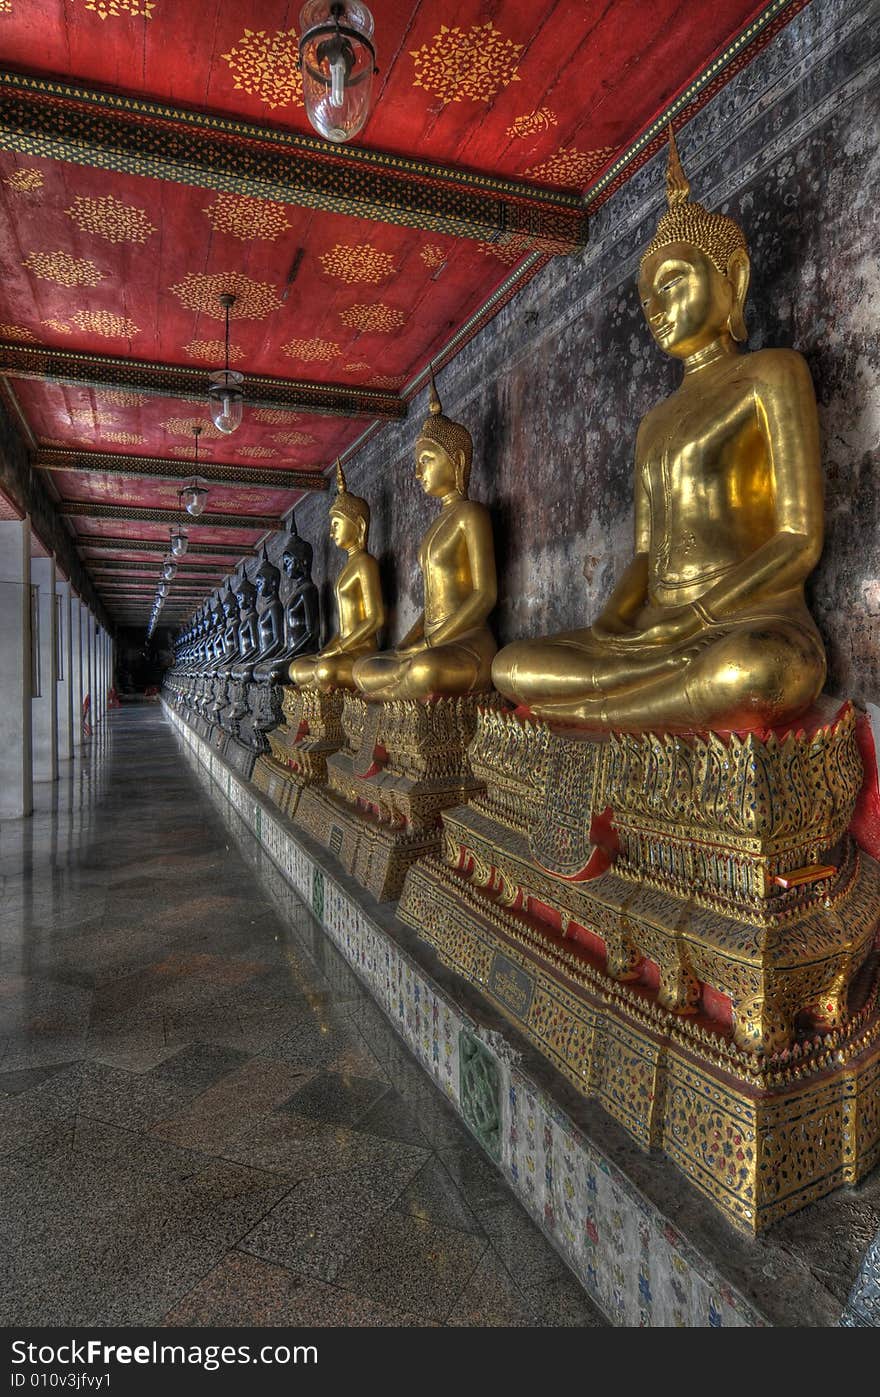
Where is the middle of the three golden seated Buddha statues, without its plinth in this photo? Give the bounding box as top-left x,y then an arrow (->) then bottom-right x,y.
353,373 -> 497,701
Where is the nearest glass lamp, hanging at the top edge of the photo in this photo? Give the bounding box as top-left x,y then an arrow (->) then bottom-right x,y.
299,0 -> 377,141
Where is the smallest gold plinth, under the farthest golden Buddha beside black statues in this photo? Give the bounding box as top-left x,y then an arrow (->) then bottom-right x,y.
253,687 -> 345,814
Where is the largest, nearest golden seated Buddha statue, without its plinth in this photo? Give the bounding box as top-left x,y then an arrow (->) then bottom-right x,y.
492,131 -> 826,732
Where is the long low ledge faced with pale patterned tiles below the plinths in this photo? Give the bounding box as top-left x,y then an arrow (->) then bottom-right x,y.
166,707 -> 877,1327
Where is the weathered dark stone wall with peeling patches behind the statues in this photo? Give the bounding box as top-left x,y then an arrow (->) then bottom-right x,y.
277,0 -> 880,700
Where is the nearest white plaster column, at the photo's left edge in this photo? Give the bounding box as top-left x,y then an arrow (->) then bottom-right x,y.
0,518 -> 34,819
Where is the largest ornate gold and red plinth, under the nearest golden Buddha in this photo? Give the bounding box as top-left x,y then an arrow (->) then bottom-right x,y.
398,705 -> 880,1231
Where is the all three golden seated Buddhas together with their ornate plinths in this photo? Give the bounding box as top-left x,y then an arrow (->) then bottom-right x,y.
165,133 -> 880,1231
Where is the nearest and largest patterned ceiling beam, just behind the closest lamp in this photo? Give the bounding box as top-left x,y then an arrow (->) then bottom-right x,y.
0,70 -> 587,253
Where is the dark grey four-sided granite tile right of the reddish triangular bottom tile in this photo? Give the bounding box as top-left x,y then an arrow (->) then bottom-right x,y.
337,1213 -> 486,1323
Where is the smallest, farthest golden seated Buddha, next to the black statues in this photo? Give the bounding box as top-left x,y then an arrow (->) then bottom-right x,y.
289,461 -> 386,693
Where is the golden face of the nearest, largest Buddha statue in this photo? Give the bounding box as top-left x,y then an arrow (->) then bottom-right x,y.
638,243 -> 733,359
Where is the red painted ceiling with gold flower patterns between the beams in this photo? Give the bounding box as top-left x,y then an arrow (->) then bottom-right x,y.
0,0 -> 803,616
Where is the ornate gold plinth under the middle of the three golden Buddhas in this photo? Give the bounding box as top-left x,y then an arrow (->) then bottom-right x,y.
295,693 -> 492,902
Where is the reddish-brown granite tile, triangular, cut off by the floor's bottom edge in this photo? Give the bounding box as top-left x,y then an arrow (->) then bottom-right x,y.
163,1252 -> 429,1329
